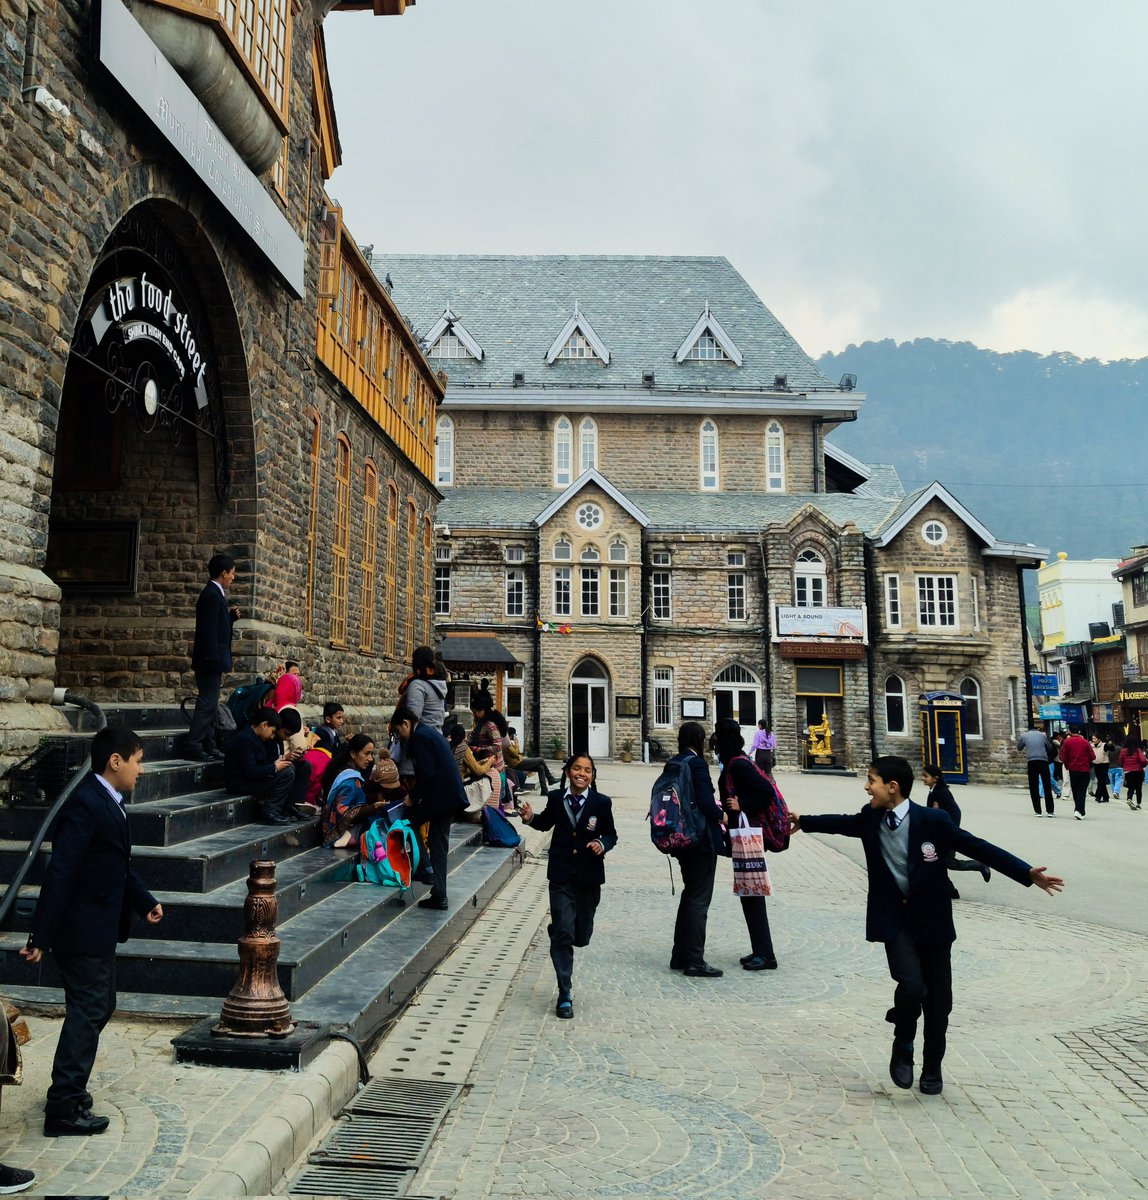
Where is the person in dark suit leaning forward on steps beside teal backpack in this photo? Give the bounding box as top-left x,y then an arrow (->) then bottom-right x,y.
391,704 -> 467,908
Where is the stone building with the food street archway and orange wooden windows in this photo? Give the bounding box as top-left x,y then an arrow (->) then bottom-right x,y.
0,0 -> 443,760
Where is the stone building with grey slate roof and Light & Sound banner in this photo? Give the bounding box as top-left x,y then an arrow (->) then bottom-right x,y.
374,254 -> 1044,778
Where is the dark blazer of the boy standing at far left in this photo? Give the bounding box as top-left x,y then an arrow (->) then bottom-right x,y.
29,775 -> 157,958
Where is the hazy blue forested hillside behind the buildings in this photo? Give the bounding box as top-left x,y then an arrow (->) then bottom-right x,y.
818,338 -> 1148,558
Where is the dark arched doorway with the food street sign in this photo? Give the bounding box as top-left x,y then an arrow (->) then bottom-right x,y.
46,202 -> 254,702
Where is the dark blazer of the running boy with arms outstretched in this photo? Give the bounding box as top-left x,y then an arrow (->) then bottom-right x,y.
801,802 -> 1033,946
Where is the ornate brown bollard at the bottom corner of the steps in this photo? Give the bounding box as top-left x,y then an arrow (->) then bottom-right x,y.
211,860 -> 295,1038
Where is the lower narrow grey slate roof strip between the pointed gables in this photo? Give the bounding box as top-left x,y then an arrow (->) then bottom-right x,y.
438,487 -> 900,534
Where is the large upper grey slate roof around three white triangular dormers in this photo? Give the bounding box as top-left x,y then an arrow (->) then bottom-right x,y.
372,253 -> 837,398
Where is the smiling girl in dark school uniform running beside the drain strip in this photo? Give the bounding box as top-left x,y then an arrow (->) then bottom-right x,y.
518,754 -> 618,1021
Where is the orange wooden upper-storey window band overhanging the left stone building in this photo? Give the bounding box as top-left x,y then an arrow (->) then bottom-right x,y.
317,206 -> 443,479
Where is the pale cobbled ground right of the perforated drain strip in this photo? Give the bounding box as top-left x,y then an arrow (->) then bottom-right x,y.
412,766 -> 1148,1200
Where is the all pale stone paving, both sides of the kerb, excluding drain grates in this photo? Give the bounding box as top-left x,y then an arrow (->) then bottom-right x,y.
0,764 -> 1148,1200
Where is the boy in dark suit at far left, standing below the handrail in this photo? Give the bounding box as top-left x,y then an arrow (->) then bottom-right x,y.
20,726 -> 163,1138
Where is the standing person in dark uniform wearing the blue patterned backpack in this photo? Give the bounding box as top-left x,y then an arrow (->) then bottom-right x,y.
667,721 -> 726,979
